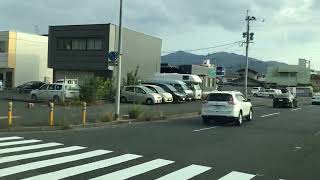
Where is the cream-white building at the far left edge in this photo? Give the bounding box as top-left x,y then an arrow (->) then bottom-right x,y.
0,31 -> 53,88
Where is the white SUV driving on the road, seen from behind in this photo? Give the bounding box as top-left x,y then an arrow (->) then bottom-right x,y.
201,91 -> 253,126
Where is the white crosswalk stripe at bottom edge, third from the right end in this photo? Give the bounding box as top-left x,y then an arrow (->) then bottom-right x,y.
90,159 -> 174,180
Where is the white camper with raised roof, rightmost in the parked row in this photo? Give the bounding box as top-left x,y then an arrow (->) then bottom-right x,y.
154,73 -> 202,100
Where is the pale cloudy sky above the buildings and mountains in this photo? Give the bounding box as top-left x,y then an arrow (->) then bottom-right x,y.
0,0 -> 320,70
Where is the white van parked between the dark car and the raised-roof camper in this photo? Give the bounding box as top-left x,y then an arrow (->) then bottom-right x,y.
144,79 -> 195,100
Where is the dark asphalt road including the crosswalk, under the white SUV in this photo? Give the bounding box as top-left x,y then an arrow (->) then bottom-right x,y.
0,105 -> 320,180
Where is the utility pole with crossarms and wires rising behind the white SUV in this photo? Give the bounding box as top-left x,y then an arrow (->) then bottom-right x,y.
243,10 -> 256,99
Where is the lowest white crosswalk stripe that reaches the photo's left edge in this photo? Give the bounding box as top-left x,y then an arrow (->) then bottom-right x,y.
0,150 -> 111,177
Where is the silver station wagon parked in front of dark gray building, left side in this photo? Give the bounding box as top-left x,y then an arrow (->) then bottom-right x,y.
30,83 -> 80,103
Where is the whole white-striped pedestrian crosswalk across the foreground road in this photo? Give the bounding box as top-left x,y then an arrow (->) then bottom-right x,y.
0,136 -> 268,180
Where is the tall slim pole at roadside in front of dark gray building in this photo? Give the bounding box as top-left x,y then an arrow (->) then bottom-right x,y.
115,0 -> 123,120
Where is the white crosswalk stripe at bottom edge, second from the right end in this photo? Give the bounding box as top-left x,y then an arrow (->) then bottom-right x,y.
157,165 -> 211,180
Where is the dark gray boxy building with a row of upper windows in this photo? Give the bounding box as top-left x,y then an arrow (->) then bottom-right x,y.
48,24 -> 162,83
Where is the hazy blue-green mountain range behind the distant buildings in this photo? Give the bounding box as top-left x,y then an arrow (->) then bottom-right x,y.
161,51 -> 285,74
